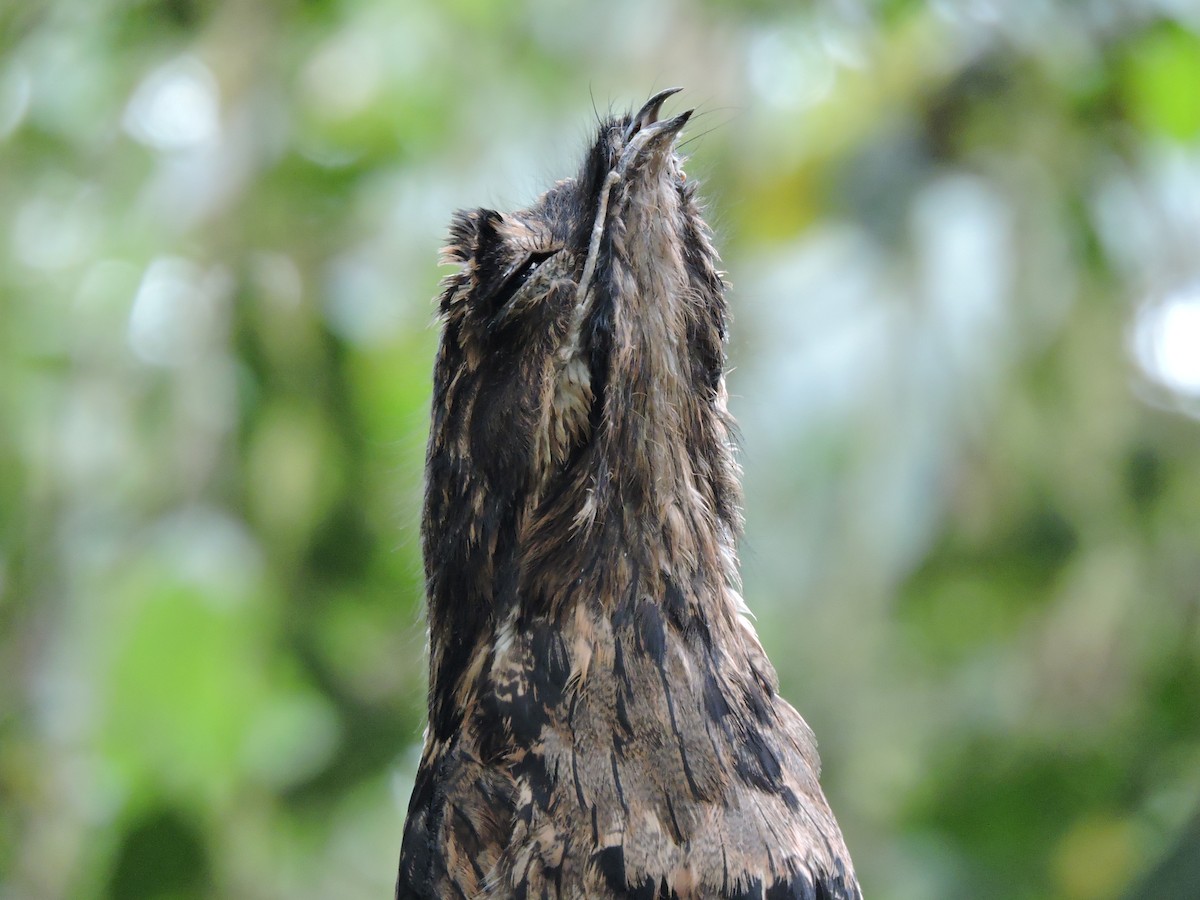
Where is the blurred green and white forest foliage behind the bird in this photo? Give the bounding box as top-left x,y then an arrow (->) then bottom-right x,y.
0,0 -> 1200,900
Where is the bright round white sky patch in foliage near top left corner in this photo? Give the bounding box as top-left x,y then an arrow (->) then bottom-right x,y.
121,56 -> 221,151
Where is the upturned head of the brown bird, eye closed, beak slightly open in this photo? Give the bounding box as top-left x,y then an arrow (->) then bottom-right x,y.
432,89 -> 725,524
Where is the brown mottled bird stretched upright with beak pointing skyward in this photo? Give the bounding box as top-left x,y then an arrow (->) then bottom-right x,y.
396,88 -> 862,900
